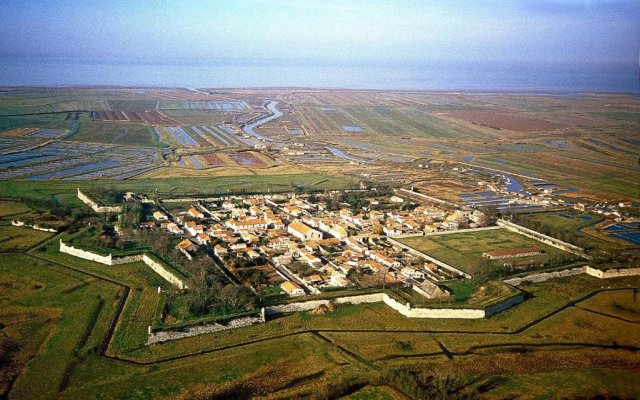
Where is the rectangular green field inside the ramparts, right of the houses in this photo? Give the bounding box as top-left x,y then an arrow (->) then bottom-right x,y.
400,229 -> 572,274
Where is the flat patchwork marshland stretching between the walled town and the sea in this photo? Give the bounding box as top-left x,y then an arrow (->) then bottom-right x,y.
0,88 -> 640,201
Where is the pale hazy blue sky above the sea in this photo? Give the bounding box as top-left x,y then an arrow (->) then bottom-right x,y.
0,0 -> 640,63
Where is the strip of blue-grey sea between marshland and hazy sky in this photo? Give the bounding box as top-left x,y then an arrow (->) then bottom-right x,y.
0,57 -> 640,93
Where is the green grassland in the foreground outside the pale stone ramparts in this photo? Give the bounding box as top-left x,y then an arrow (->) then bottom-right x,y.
0,219 -> 640,399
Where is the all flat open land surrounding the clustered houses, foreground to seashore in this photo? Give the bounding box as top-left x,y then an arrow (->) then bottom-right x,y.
0,88 -> 640,399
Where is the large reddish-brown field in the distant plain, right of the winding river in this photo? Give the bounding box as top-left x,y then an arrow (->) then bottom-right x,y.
443,111 -> 567,132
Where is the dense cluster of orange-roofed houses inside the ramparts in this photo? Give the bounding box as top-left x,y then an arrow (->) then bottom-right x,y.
141,195 -> 478,296
